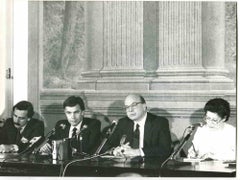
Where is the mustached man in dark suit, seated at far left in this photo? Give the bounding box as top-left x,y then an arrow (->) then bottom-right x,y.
0,101 -> 44,152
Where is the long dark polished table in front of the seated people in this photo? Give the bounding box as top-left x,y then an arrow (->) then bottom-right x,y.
0,153 -> 236,177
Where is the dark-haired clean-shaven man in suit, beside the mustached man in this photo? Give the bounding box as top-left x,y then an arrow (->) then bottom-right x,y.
40,96 -> 101,154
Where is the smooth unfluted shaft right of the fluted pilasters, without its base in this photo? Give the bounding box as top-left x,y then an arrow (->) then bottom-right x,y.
202,2 -> 225,73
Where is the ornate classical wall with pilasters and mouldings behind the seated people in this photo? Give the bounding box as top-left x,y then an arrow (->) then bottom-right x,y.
26,1 -> 236,139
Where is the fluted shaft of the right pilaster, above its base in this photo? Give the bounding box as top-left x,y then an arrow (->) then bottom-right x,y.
158,2 -> 202,71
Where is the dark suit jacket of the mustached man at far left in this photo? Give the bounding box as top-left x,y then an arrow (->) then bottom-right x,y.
0,118 -> 44,152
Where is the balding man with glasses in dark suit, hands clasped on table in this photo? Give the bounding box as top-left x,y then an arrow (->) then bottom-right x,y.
106,94 -> 171,158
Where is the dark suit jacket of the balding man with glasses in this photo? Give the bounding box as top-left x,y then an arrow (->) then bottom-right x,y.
104,113 -> 171,158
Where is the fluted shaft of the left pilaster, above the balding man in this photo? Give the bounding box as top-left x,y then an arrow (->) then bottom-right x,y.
101,1 -> 143,76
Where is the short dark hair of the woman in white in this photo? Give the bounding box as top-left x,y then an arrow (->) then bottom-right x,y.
204,98 -> 230,121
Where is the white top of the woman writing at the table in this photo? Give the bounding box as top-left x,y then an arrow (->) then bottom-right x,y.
188,123 -> 236,160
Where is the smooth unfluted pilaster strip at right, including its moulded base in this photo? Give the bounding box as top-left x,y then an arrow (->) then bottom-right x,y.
202,2 -> 235,88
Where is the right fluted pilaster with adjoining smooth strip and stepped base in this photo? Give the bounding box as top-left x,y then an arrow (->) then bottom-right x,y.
150,1 -> 234,90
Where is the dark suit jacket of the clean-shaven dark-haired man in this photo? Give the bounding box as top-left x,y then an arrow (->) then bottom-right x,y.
51,118 -> 101,154
